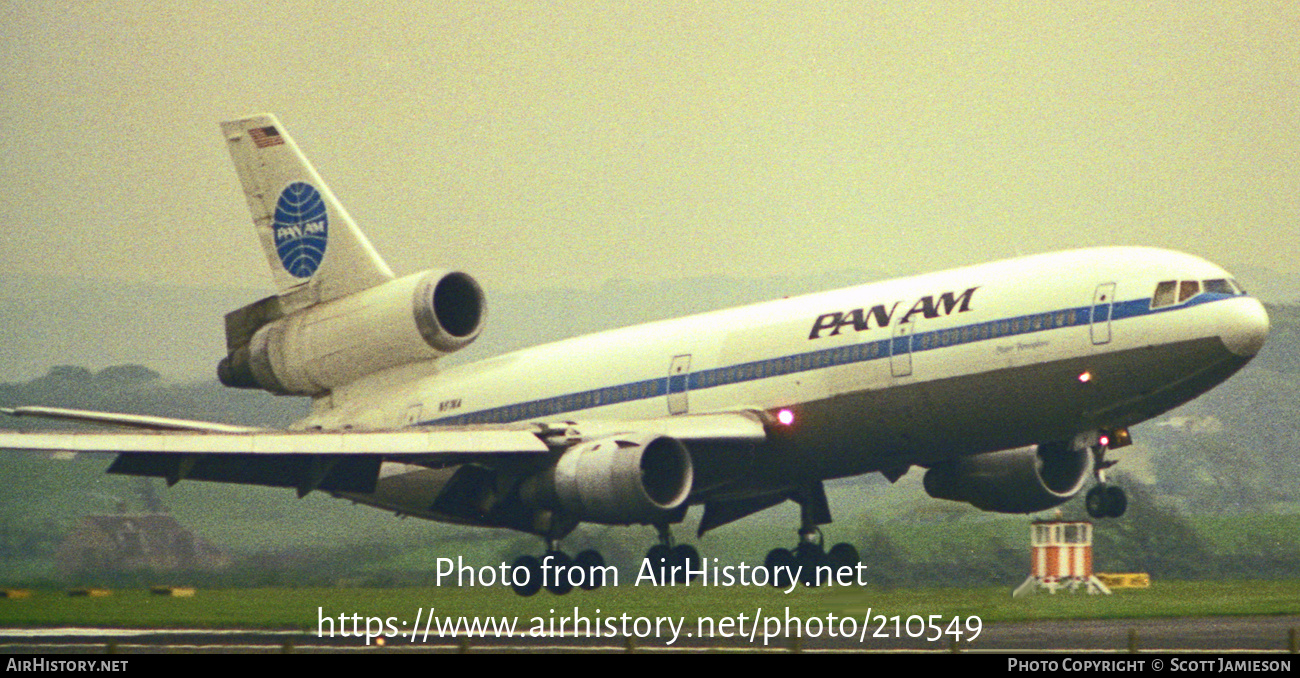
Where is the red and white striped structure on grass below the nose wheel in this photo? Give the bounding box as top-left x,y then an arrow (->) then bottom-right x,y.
1011,517 -> 1110,597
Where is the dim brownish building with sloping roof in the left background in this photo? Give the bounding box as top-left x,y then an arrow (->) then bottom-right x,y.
55,513 -> 230,574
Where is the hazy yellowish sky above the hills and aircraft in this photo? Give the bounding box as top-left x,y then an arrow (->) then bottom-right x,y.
0,0 -> 1300,294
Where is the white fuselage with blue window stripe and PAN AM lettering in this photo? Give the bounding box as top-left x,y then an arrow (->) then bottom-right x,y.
314,248 -> 1268,518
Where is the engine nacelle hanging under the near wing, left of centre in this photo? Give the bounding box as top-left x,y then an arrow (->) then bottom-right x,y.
520,435 -> 694,525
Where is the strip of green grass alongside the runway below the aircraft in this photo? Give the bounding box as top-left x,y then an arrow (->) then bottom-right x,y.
0,581 -> 1300,631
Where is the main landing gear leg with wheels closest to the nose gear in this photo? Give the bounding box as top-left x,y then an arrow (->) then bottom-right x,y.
763,483 -> 862,588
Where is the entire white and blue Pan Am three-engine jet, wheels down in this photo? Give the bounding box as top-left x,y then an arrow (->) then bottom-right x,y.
0,116 -> 1269,595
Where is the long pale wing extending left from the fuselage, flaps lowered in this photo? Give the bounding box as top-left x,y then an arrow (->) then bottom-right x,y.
0,408 -> 767,496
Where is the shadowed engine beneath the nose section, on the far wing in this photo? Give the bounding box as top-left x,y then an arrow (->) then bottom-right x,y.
924,443 -> 1092,513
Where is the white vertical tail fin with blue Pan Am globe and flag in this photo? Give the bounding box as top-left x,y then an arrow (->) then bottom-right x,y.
221,114 -> 393,305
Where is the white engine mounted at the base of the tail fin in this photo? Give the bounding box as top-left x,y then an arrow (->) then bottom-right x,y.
217,271 -> 488,395
